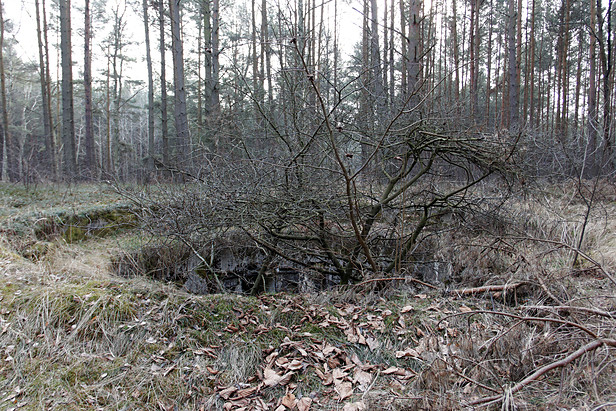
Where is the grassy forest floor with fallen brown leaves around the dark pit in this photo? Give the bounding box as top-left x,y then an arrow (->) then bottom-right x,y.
0,185 -> 616,411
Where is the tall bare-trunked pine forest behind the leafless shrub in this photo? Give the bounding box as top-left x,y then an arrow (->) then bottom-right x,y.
0,0 -> 616,181
